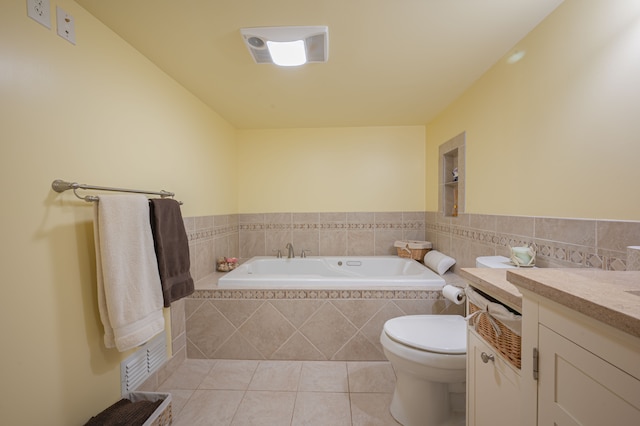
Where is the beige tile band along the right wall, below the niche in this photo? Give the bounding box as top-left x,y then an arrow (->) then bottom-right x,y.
425,212 -> 640,271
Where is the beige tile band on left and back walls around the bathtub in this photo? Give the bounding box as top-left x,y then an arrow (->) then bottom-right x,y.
184,212 -> 425,281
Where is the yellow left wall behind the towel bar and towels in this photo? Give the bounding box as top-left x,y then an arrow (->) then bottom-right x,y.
0,0 -> 238,425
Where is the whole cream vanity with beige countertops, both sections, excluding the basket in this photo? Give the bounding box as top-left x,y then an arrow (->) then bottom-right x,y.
462,268 -> 640,426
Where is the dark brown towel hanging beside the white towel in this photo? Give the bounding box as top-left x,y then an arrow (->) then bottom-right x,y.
150,198 -> 195,307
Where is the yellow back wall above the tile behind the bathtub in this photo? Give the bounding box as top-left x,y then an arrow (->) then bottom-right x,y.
238,126 -> 425,213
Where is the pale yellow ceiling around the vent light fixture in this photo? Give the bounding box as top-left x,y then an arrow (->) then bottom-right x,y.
76,0 -> 562,129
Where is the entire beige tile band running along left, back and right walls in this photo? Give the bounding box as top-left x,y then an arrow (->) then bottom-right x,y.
185,212 -> 640,281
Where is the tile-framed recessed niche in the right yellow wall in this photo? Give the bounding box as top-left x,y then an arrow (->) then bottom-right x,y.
438,132 -> 466,217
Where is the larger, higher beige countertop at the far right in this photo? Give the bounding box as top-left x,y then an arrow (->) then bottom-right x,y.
508,268 -> 640,337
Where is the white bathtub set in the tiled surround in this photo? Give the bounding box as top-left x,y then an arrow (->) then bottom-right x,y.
218,256 -> 444,290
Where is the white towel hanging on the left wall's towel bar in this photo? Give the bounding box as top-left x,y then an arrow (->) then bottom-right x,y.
93,195 -> 164,352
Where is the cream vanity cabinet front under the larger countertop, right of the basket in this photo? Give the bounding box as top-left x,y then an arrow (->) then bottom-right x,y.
522,291 -> 640,426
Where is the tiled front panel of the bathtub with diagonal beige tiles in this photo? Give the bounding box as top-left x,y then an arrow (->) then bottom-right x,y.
185,284 -> 463,361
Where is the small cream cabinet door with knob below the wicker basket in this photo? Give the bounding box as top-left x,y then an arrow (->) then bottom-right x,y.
467,331 -> 521,426
